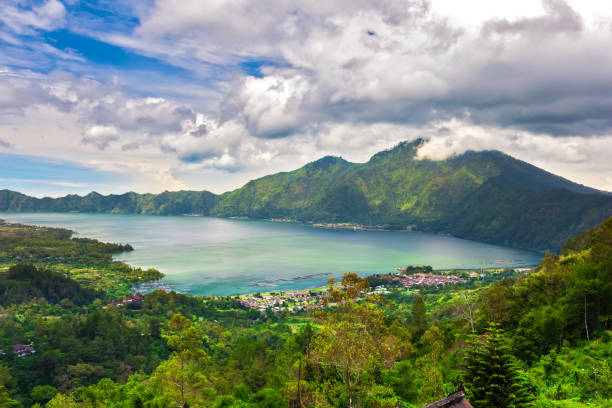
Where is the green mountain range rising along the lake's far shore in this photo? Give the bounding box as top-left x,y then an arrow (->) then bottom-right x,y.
0,140 -> 612,250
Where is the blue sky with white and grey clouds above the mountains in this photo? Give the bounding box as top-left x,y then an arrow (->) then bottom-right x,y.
0,0 -> 612,196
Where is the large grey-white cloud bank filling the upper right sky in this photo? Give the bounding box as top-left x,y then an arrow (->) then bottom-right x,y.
113,0 -> 612,137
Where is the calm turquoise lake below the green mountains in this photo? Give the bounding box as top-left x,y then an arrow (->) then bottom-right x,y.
0,213 -> 541,295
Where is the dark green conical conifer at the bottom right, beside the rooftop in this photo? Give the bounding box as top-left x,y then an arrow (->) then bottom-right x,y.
464,325 -> 532,408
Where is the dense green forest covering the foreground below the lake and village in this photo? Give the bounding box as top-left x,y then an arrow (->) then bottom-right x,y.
0,215 -> 612,408
